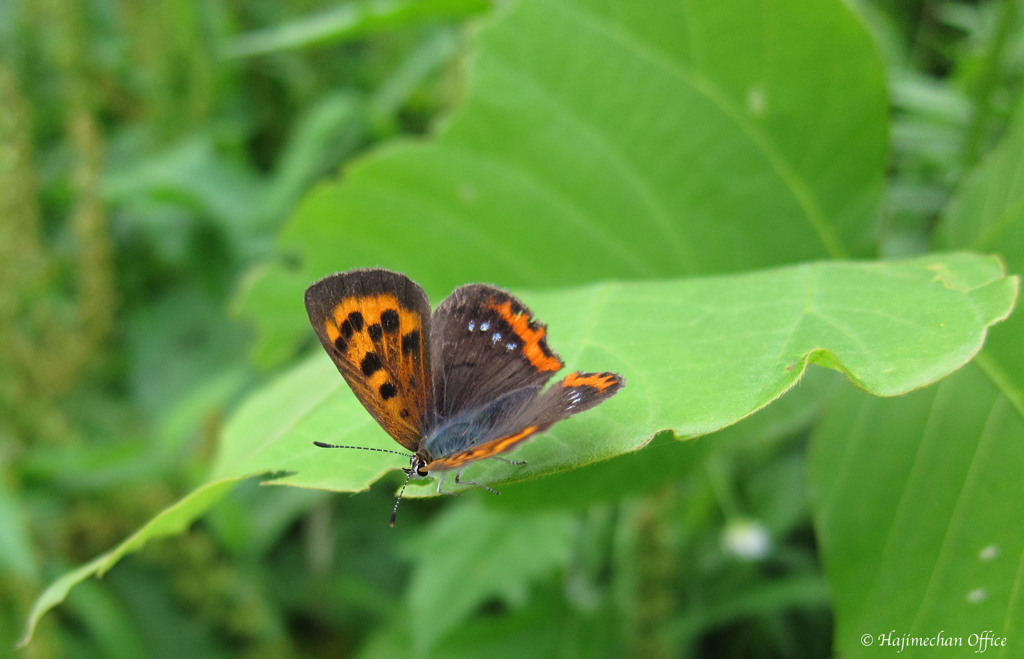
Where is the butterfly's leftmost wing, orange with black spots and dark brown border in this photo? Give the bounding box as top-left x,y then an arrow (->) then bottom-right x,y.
305,269 -> 432,451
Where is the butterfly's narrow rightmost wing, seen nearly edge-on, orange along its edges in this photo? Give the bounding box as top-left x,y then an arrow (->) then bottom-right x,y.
426,371 -> 626,471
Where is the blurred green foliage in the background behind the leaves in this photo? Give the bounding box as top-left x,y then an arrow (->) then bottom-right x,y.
0,0 -> 1024,657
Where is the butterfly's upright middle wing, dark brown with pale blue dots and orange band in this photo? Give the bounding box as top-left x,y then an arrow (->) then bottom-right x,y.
431,283 -> 562,420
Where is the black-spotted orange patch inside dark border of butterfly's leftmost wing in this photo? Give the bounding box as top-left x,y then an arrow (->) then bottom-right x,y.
324,293 -> 430,450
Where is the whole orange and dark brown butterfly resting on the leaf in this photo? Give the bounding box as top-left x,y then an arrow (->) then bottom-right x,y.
305,268 -> 625,526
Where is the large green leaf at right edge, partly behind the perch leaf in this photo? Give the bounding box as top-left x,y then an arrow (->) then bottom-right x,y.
810,100 -> 1024,656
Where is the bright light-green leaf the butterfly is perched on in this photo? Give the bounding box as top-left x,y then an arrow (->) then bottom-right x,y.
214,255 -> 1017,499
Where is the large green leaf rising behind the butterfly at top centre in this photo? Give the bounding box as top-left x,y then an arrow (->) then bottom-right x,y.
244,0 -> 887,366
